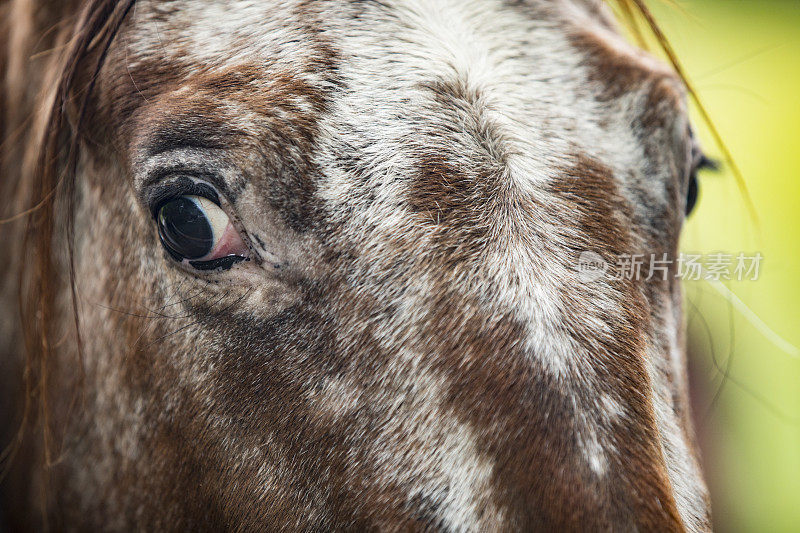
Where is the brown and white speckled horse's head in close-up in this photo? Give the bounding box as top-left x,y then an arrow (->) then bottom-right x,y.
0,0 -> 710,531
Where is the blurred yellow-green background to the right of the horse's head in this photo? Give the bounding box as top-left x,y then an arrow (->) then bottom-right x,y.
649,0 -> 800,532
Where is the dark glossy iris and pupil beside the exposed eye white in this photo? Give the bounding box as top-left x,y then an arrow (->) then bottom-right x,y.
158,197 -> 214,261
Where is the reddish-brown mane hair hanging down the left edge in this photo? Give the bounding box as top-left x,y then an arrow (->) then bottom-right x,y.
0,0 -> 134,520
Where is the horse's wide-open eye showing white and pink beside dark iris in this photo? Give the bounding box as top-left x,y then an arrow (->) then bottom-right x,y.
157,195 -> 248,270
